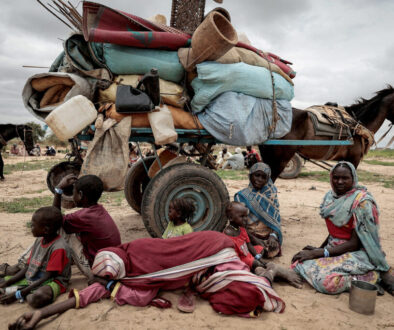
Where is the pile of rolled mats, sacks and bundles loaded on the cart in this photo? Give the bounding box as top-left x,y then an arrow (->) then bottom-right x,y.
23,1 -> 295,145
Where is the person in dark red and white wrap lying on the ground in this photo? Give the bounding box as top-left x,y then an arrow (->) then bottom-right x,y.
9,231 -> 292,329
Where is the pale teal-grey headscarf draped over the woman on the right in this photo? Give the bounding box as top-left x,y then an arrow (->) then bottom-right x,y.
320,161 -> 390,271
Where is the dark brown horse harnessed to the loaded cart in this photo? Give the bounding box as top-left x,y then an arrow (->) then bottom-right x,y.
259,85 -> 394,181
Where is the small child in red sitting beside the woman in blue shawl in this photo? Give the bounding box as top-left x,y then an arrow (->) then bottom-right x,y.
223,202 -> 265,271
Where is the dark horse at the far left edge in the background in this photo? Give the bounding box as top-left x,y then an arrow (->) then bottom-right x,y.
0,124 -> 34,180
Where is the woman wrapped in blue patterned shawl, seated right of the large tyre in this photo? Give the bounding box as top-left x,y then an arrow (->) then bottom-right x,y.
234,163 -> 282,258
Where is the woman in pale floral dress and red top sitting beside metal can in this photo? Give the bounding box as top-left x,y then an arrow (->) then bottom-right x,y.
292,162 -> 392,294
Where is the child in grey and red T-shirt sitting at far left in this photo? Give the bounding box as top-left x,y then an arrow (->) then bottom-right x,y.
0,206 -> 71,308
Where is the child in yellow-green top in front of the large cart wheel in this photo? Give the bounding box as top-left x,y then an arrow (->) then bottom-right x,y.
163,198 -> 195,238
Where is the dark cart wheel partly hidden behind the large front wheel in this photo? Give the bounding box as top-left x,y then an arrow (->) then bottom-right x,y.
124,156 -> 156,213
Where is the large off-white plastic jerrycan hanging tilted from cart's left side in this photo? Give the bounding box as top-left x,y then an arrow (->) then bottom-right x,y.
45,95 -> 97,141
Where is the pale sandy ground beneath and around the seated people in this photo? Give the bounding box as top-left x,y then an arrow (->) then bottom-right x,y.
0,158 -> 394,330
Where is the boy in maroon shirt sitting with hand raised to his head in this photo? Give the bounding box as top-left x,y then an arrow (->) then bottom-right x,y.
1,174 -> 121,278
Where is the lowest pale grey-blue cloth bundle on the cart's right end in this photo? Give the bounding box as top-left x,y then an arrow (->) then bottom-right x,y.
198,92 -> 293,146
